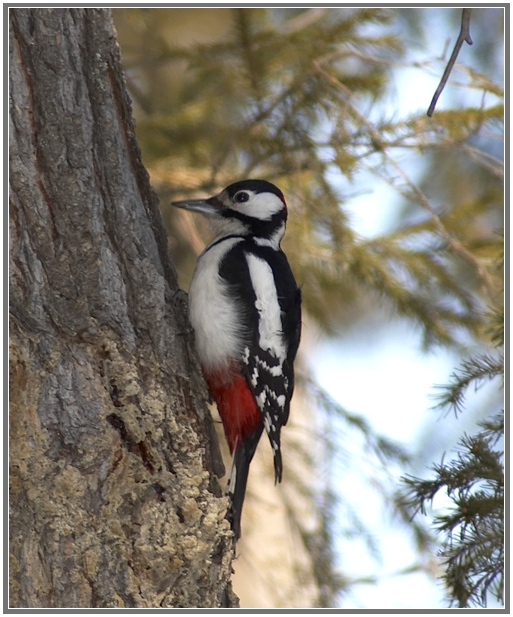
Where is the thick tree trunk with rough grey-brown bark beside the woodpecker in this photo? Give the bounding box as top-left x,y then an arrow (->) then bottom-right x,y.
9,8 -> 237,608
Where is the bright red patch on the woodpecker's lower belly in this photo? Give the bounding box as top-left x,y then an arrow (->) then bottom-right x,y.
205,371 -> 262,453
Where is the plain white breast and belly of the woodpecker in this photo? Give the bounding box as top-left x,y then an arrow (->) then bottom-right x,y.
189,238 -> 243,371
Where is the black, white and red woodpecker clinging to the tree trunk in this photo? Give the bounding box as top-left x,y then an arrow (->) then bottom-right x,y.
173,180 -> 301,539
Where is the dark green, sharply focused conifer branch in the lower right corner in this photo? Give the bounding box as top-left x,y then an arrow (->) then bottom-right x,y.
403,414 -> 504,608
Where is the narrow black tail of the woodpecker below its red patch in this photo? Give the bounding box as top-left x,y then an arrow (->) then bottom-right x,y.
226,426 -> 263,540
